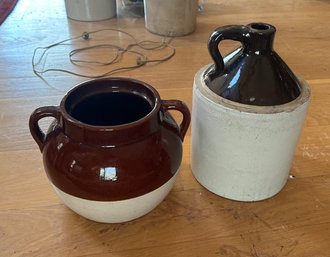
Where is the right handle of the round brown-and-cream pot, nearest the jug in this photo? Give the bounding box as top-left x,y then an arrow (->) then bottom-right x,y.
162,100 -> 190,141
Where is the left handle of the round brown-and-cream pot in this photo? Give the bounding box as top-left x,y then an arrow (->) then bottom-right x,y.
29,106 -> 61,152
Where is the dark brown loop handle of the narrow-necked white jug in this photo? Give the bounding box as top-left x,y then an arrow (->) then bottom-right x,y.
207,25 -> 250,79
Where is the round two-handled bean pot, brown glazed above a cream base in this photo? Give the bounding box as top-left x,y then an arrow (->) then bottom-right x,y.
29,78 -> 190,223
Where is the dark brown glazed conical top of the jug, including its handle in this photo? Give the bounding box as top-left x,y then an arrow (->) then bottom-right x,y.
204,23 -> 300,106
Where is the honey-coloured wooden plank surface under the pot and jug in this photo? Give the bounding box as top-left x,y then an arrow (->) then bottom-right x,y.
0,0 -> 330,257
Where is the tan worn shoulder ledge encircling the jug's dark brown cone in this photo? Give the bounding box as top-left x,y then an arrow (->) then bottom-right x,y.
195,64 -> 311,114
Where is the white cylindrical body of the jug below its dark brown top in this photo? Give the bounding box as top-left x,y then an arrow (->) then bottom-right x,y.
191,65 -> 310,201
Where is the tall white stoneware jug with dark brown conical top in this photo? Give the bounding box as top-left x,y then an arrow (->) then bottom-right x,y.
191,23 -> 310,201
